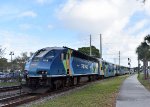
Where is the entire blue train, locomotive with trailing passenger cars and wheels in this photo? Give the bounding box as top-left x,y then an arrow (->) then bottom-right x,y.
24,47 -> 128,93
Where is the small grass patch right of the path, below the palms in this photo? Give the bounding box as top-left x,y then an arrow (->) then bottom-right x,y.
138,74 -> 150,91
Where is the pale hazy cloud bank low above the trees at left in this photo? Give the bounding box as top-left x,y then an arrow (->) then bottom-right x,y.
0,30 -> 44,59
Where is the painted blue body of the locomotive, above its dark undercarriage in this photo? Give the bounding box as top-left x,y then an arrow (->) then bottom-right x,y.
25,48 -> 99,77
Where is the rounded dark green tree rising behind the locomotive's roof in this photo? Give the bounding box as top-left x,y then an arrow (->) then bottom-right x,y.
78,46 -> 100,58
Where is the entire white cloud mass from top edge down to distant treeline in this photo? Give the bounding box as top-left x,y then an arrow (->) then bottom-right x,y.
57,0 -> 149,66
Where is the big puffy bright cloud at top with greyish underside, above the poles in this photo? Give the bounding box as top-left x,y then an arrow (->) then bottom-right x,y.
58,0 -> 141,33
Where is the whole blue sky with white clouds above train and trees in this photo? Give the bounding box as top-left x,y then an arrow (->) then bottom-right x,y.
0,0 -> 150,67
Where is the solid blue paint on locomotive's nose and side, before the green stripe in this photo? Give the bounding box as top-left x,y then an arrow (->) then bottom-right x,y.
25,48 -> 66,77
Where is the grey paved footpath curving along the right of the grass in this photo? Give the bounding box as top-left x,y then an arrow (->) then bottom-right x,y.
116,74 -> 150,107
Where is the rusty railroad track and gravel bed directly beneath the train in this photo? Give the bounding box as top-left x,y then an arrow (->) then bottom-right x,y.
0,79 -> 117,107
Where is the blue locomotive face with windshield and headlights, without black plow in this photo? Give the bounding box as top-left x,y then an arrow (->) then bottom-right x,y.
25,49 -> 55,77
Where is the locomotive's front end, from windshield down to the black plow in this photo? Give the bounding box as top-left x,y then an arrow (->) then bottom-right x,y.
25,48 -> 62,93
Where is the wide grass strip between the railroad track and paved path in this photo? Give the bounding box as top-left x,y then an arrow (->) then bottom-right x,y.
33,76 -> 127,107
